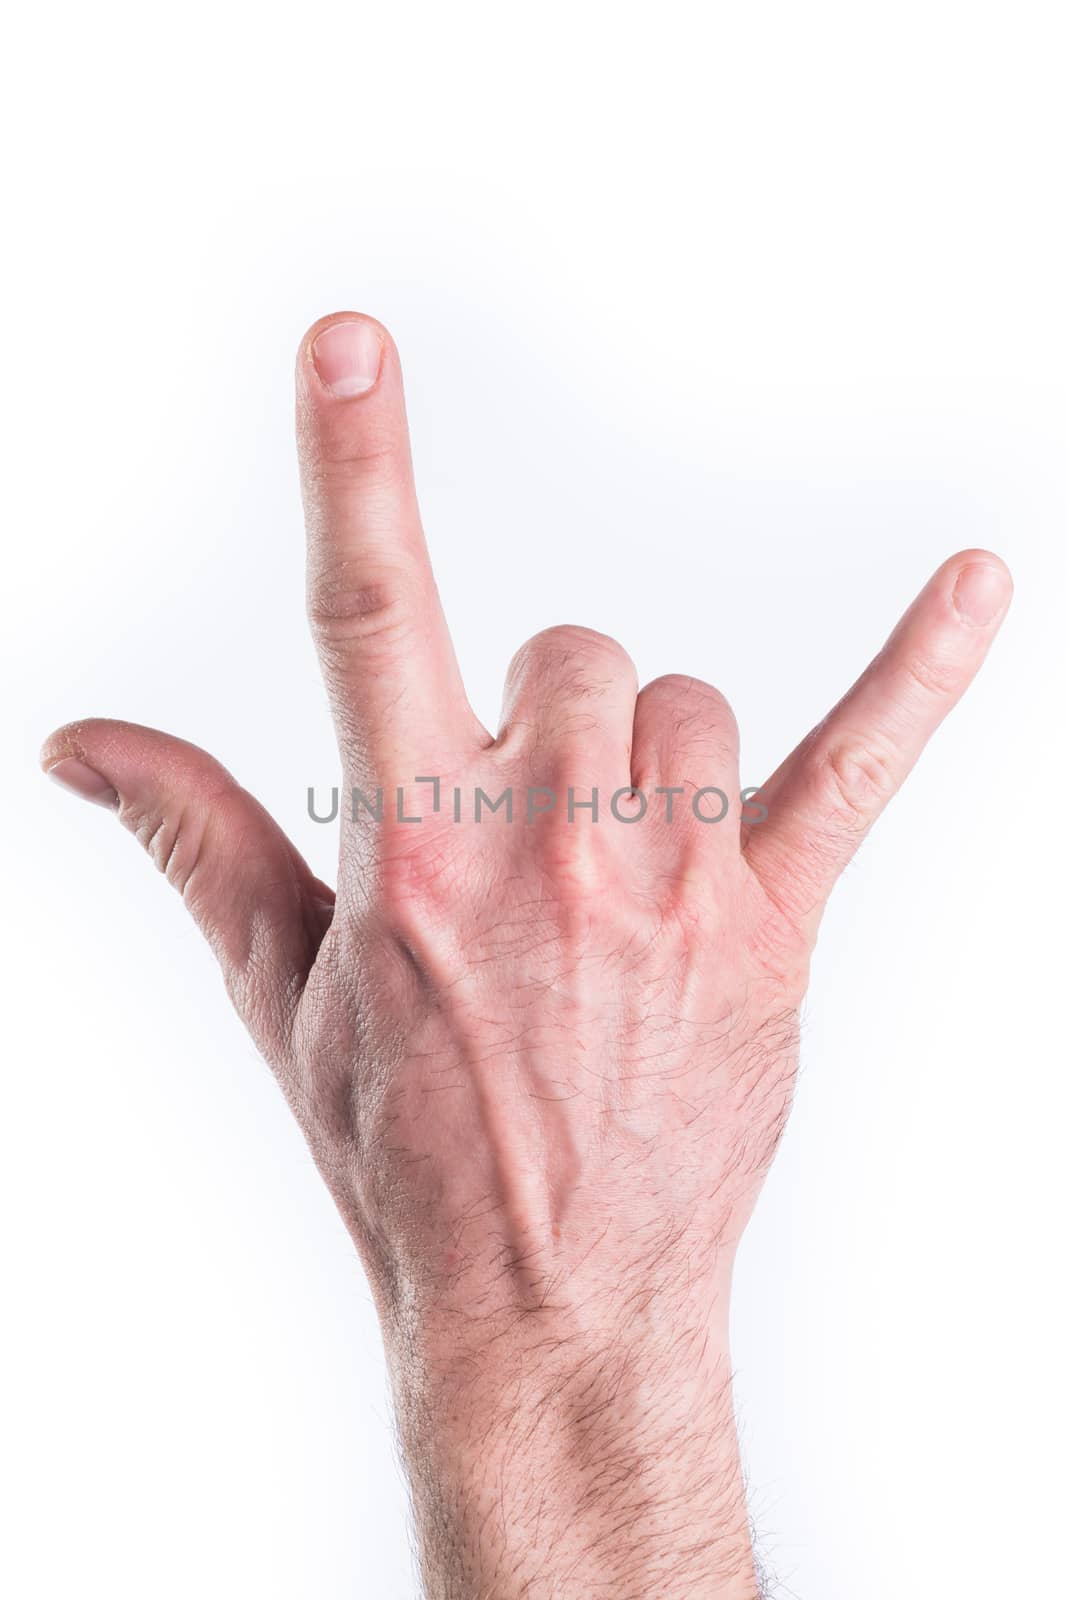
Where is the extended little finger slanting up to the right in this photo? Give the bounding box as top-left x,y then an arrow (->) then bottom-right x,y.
745,550 -> 1012,922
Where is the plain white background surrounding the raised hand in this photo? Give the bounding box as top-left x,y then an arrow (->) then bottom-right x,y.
0,0 -> 1068,1600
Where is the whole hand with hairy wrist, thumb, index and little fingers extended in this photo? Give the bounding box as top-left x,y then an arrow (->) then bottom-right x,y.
43,315 -> 1010,1600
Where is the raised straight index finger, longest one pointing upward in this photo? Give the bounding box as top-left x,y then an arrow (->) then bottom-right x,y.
297,312 -> 488,781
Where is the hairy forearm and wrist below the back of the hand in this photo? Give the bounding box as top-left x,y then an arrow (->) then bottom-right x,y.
392,1334 -> 759,1600
